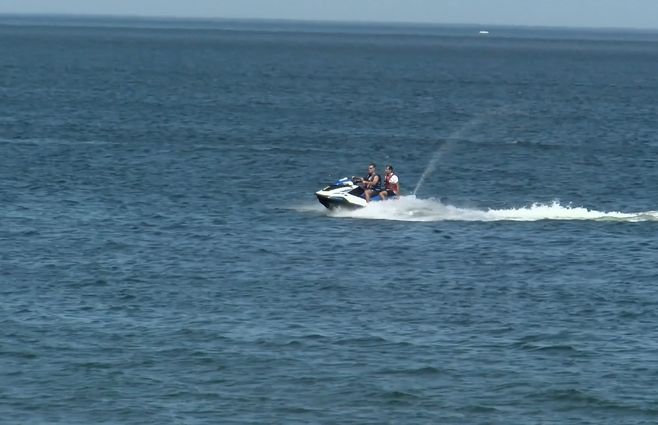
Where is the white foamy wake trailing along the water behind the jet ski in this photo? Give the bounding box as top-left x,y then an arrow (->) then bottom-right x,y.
327,196 -> 658,222
